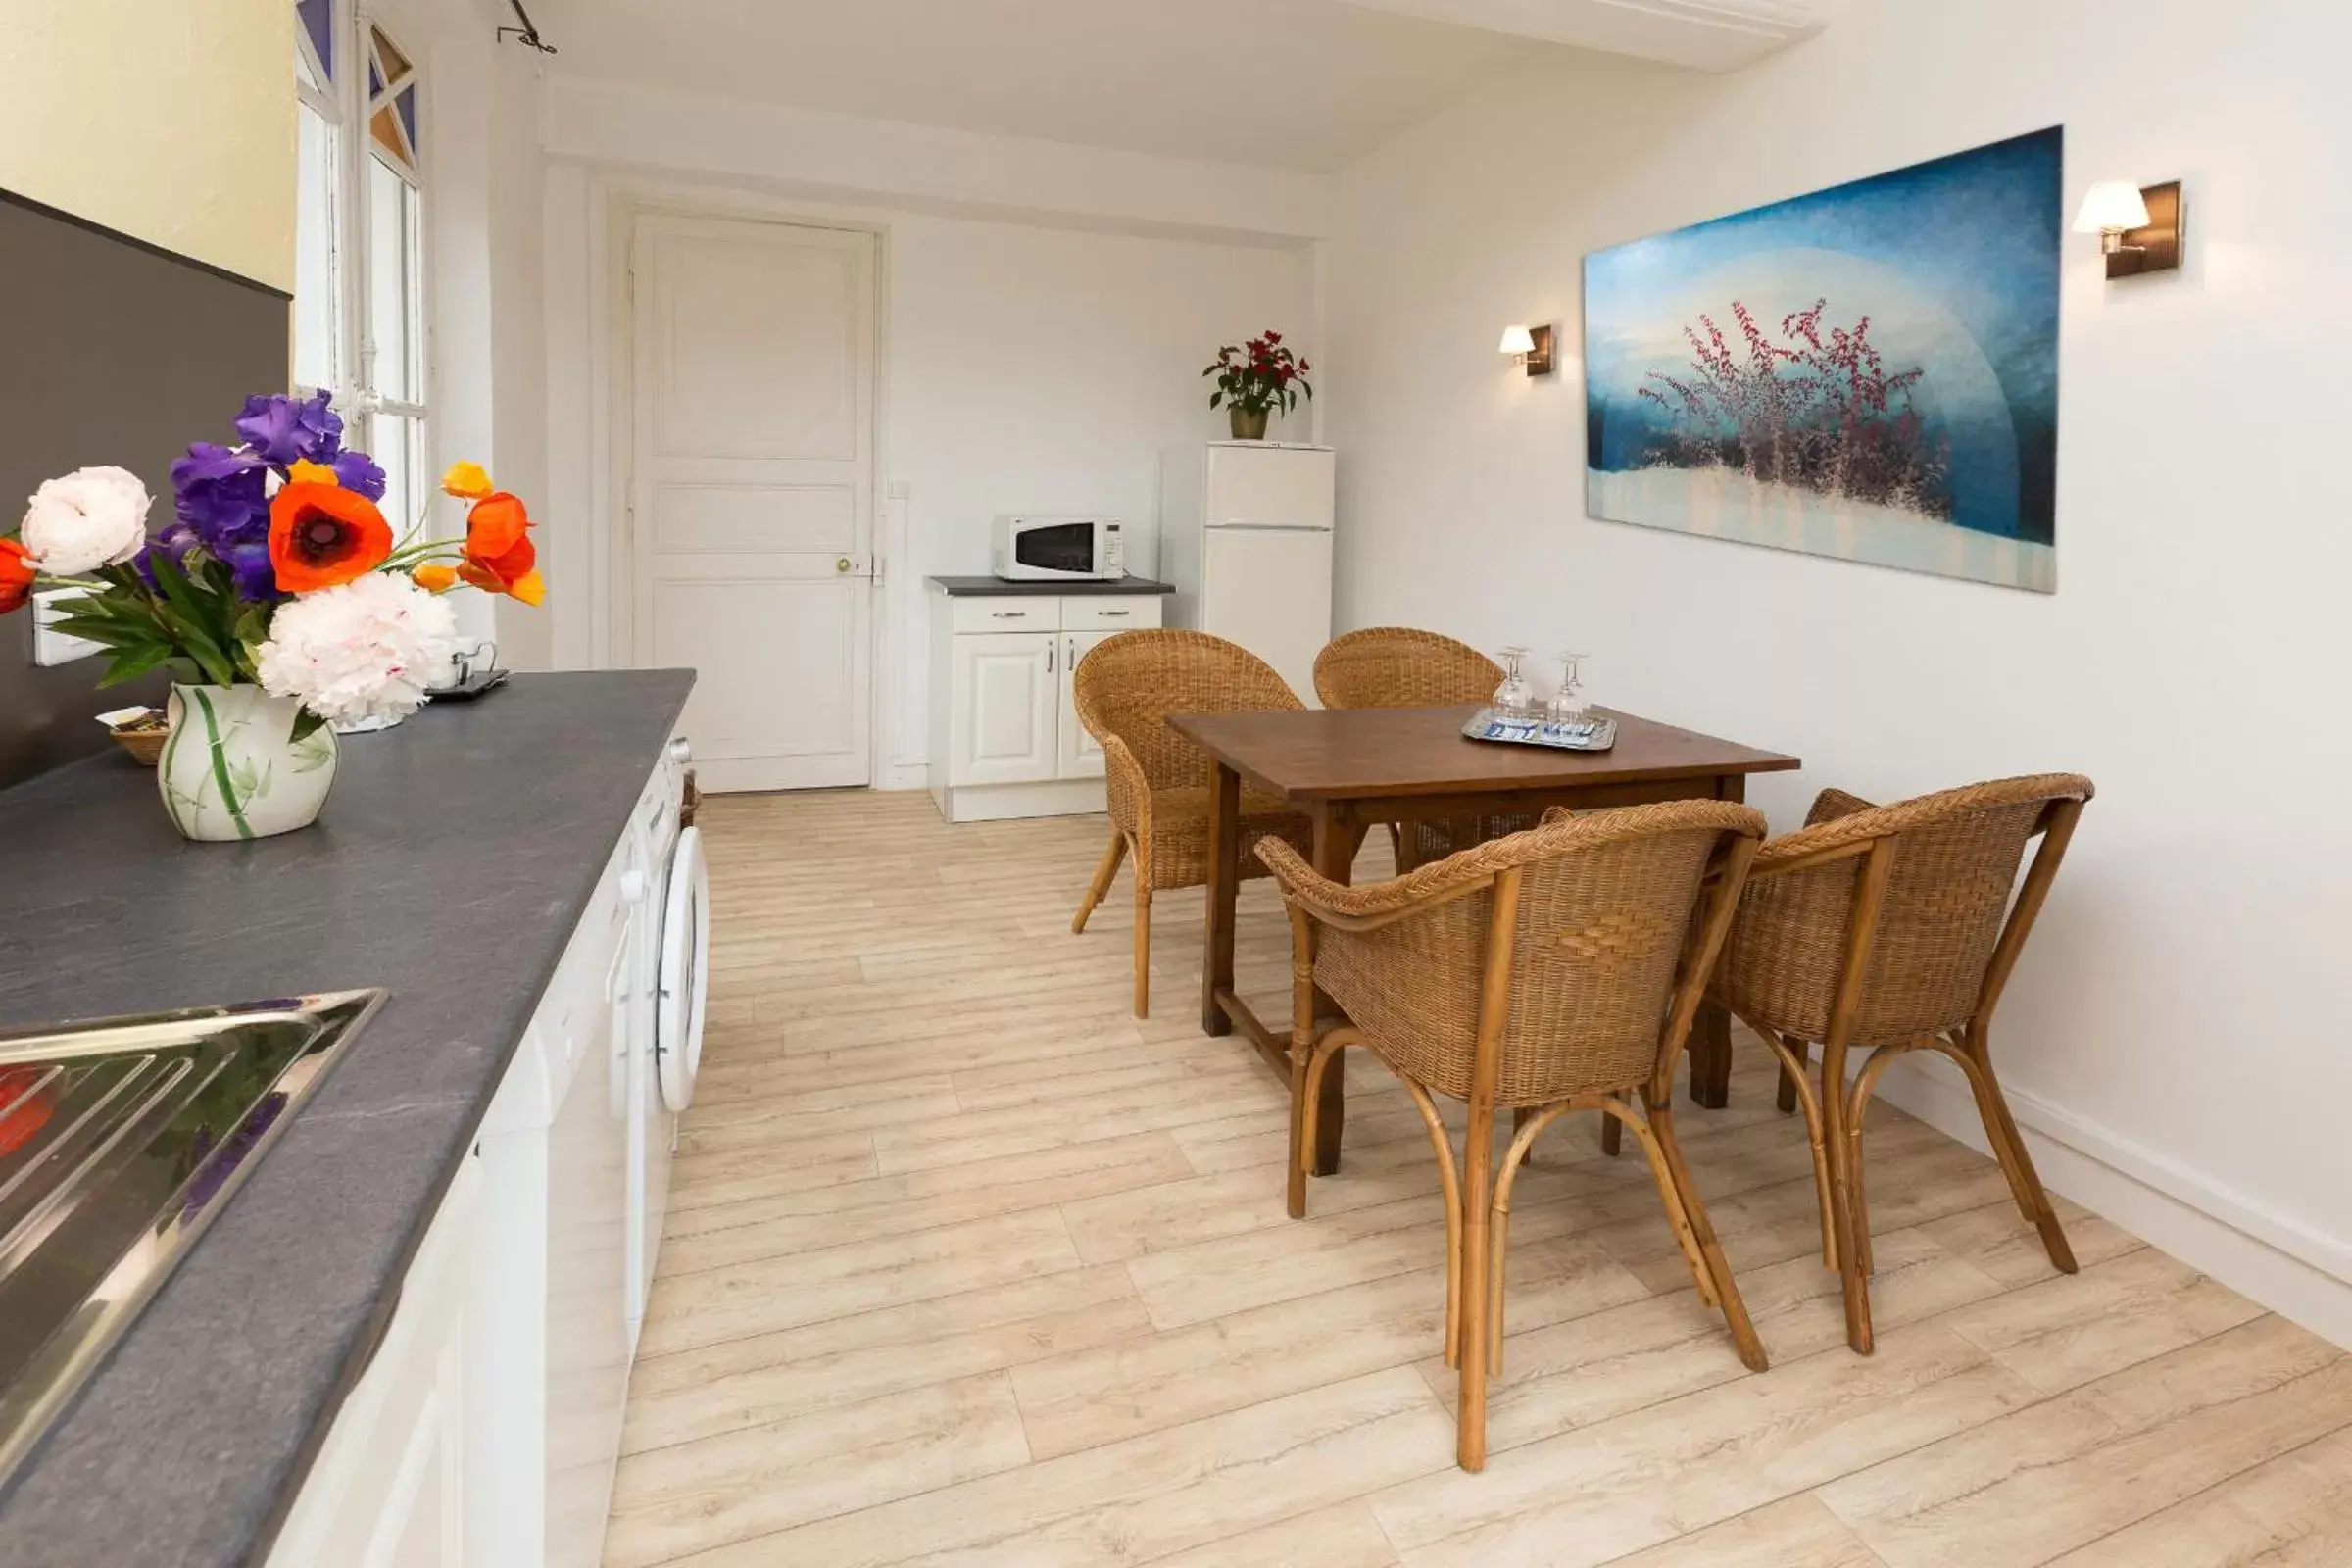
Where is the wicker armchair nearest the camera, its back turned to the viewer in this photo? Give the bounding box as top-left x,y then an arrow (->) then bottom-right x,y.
1258,802 -> 1764,1469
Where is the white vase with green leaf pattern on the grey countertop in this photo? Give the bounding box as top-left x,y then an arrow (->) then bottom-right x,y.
155,686 -> 336,844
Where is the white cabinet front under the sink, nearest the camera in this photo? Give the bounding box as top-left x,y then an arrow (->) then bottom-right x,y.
269,1156 -> 482,1568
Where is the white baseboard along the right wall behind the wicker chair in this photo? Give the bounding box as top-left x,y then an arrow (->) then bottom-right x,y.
1880,1051 -> 2352,1349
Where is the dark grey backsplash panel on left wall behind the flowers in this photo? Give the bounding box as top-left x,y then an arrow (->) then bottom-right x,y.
0,190 -> 289,788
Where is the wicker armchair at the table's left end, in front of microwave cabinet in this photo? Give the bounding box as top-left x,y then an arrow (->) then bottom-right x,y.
1070,630 -> 1312,1018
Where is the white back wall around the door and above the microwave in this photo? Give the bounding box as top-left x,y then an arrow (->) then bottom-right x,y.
546,82 -> 1322,788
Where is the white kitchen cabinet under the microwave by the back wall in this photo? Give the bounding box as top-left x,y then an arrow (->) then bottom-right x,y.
931,590 -> 1162,823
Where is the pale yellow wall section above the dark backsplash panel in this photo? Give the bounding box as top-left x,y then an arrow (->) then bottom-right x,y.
0,0 -> 294,289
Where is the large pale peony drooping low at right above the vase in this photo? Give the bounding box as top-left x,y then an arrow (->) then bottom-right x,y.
254,571 -> 457,724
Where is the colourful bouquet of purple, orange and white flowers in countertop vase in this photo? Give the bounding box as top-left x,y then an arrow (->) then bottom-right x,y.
0,393 -> 546,741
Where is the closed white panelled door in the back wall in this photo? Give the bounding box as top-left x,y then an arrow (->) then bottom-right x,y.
623,217 -> 875,790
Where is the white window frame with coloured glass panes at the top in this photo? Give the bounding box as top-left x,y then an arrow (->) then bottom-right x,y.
287,0 -> 435,510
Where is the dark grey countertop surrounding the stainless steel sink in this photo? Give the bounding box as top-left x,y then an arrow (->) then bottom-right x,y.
0,670 -> 694,1568
